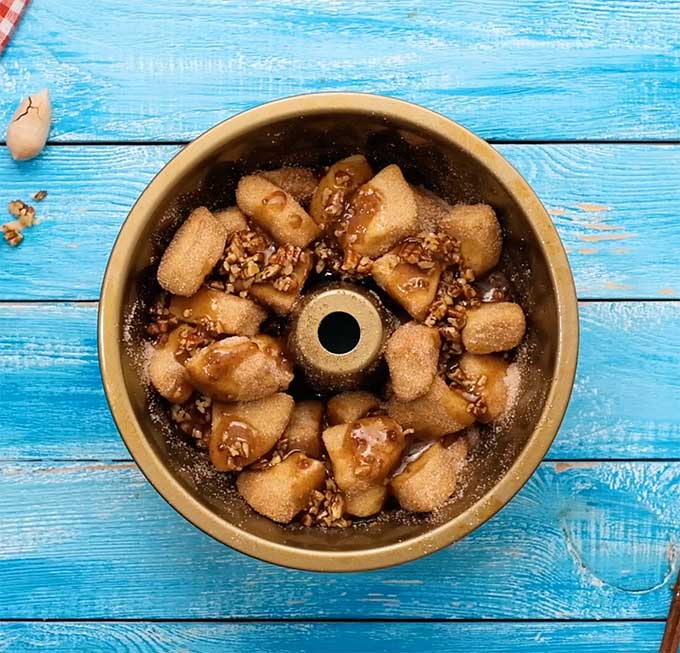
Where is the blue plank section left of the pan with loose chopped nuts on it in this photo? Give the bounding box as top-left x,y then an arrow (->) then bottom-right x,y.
0,147 -> 178,299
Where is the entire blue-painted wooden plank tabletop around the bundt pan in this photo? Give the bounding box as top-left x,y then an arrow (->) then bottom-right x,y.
0,0 -> 680,653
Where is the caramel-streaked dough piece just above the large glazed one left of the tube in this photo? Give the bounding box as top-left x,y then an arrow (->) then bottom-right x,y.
170,287 -> 267,336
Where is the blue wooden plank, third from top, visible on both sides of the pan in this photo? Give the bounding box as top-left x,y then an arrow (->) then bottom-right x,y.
0,302 -> 680,460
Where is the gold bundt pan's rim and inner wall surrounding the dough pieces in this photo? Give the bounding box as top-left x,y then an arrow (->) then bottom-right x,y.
98,93 -> 578,571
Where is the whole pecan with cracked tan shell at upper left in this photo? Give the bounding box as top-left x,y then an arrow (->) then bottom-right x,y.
6,89 -> 52,161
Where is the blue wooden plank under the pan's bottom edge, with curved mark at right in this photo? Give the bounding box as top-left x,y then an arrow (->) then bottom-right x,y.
0,462 -> 680,620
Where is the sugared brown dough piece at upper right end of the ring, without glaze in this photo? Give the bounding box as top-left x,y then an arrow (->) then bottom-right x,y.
442,204 -> 503,277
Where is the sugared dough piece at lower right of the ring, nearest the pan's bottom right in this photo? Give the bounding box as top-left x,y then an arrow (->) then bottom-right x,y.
392,440 -> 468,512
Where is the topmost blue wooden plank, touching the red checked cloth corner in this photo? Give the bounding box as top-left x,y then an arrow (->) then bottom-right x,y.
0,0 -> 680,141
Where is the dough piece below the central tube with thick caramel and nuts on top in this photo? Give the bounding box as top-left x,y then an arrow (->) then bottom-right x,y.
322,415 -> 406,494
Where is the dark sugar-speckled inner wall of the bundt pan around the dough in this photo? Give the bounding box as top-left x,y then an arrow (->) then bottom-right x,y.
119,112 -> 558,551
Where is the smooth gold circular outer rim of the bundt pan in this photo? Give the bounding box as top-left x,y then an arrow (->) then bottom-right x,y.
98,93 -> 578,571
